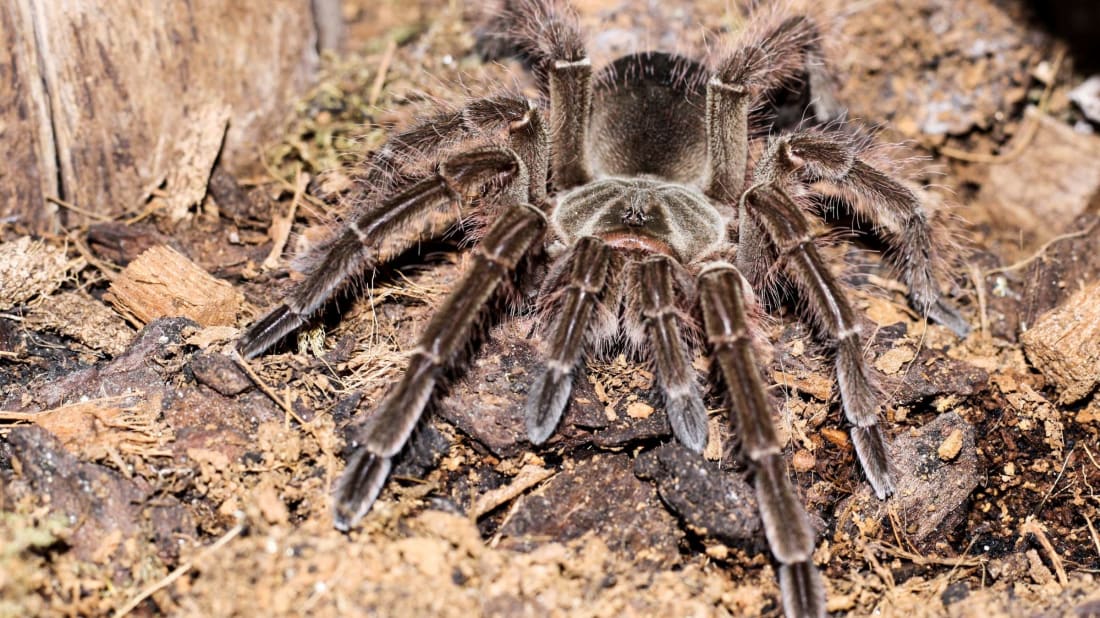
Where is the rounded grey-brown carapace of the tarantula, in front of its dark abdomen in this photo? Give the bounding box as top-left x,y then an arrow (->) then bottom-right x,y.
552,178 -> 727,262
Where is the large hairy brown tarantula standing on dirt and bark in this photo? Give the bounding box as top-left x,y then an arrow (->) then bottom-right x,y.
239,0 -> 967,616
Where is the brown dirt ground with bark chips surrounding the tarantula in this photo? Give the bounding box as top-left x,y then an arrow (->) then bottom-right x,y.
0,0 -> 1100,617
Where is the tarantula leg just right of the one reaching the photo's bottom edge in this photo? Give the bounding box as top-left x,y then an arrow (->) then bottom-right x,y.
741,183 -> 894,498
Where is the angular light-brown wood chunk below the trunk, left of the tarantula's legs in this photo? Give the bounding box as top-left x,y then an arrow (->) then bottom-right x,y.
105,245 -> 244,327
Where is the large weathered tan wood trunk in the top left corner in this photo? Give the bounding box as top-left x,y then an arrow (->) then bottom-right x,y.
0,0 -> 318,230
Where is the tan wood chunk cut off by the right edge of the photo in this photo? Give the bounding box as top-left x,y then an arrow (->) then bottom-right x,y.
1020,282 -> 1100,404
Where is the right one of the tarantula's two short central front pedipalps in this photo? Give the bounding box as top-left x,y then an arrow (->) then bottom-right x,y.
631,255 -> 706,453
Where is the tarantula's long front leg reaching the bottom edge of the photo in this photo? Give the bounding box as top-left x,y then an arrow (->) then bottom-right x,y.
699,263 -> 825,617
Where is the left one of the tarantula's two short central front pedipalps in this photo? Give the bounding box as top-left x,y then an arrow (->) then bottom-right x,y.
524,236 -> 612,444
